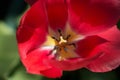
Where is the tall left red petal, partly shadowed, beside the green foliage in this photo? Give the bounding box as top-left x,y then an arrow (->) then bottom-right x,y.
17,1 -> 47,58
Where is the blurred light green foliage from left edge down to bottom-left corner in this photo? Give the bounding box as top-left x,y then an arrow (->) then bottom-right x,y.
0,21 -> 40,80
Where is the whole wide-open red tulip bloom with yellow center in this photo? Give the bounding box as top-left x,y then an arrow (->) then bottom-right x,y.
17,0 -> 120,78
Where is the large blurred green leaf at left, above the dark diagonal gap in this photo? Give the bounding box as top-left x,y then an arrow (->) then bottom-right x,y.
0,22 -> 19,77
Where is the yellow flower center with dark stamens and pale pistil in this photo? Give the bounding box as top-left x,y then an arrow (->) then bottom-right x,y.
44,23 -> 81,61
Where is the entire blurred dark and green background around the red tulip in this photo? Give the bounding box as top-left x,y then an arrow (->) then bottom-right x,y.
0,0 -> 120,80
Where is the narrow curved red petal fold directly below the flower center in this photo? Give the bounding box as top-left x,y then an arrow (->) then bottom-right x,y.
49,53 -> 101,71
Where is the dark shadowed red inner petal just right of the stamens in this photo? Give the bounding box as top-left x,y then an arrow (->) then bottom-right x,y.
76,36 -> 107,57
